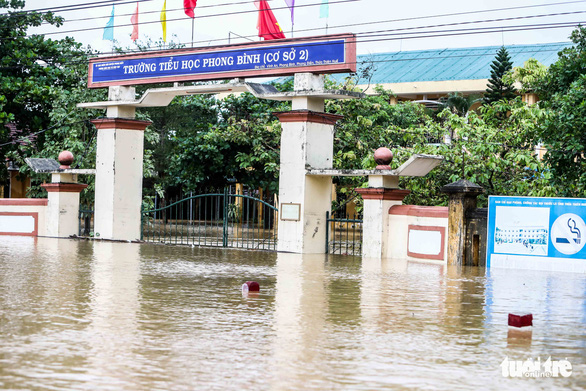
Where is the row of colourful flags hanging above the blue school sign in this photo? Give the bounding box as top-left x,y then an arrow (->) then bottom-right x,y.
102,0 -> 329,42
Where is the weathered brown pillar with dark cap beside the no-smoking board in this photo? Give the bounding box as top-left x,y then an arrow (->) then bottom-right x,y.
441,179 -> 484,266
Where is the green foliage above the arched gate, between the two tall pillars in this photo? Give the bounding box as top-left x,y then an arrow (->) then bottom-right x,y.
147,84 -> 290,198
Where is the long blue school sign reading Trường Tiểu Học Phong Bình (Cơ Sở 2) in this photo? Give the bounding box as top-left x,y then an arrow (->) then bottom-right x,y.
89,37 -> 355,87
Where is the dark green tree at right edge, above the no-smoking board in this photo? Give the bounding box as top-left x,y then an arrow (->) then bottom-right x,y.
535,26 -> 586,197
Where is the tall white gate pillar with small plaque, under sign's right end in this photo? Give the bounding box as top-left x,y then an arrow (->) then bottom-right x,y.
274,73 -> 342,254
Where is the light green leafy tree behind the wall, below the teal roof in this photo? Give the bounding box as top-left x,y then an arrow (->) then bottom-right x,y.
374,98 -> 557,205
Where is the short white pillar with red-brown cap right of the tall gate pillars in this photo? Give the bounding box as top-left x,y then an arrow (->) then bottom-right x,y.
355,175 -> 410,258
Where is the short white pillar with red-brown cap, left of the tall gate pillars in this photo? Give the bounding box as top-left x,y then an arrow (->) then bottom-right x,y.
41,174 -> 87,238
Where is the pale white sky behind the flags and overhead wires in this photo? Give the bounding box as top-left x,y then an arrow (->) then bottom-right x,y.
16,0 -> 586,54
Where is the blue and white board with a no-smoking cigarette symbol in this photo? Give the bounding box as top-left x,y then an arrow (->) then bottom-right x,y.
486,196 -> 586,271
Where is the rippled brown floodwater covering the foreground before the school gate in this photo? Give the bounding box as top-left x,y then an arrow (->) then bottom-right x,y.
0,236 -> 586,390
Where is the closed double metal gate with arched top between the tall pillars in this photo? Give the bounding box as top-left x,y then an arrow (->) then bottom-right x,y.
142,189 -> 278,251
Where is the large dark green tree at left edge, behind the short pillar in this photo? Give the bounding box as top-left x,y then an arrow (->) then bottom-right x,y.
0,0 -> 104,199
